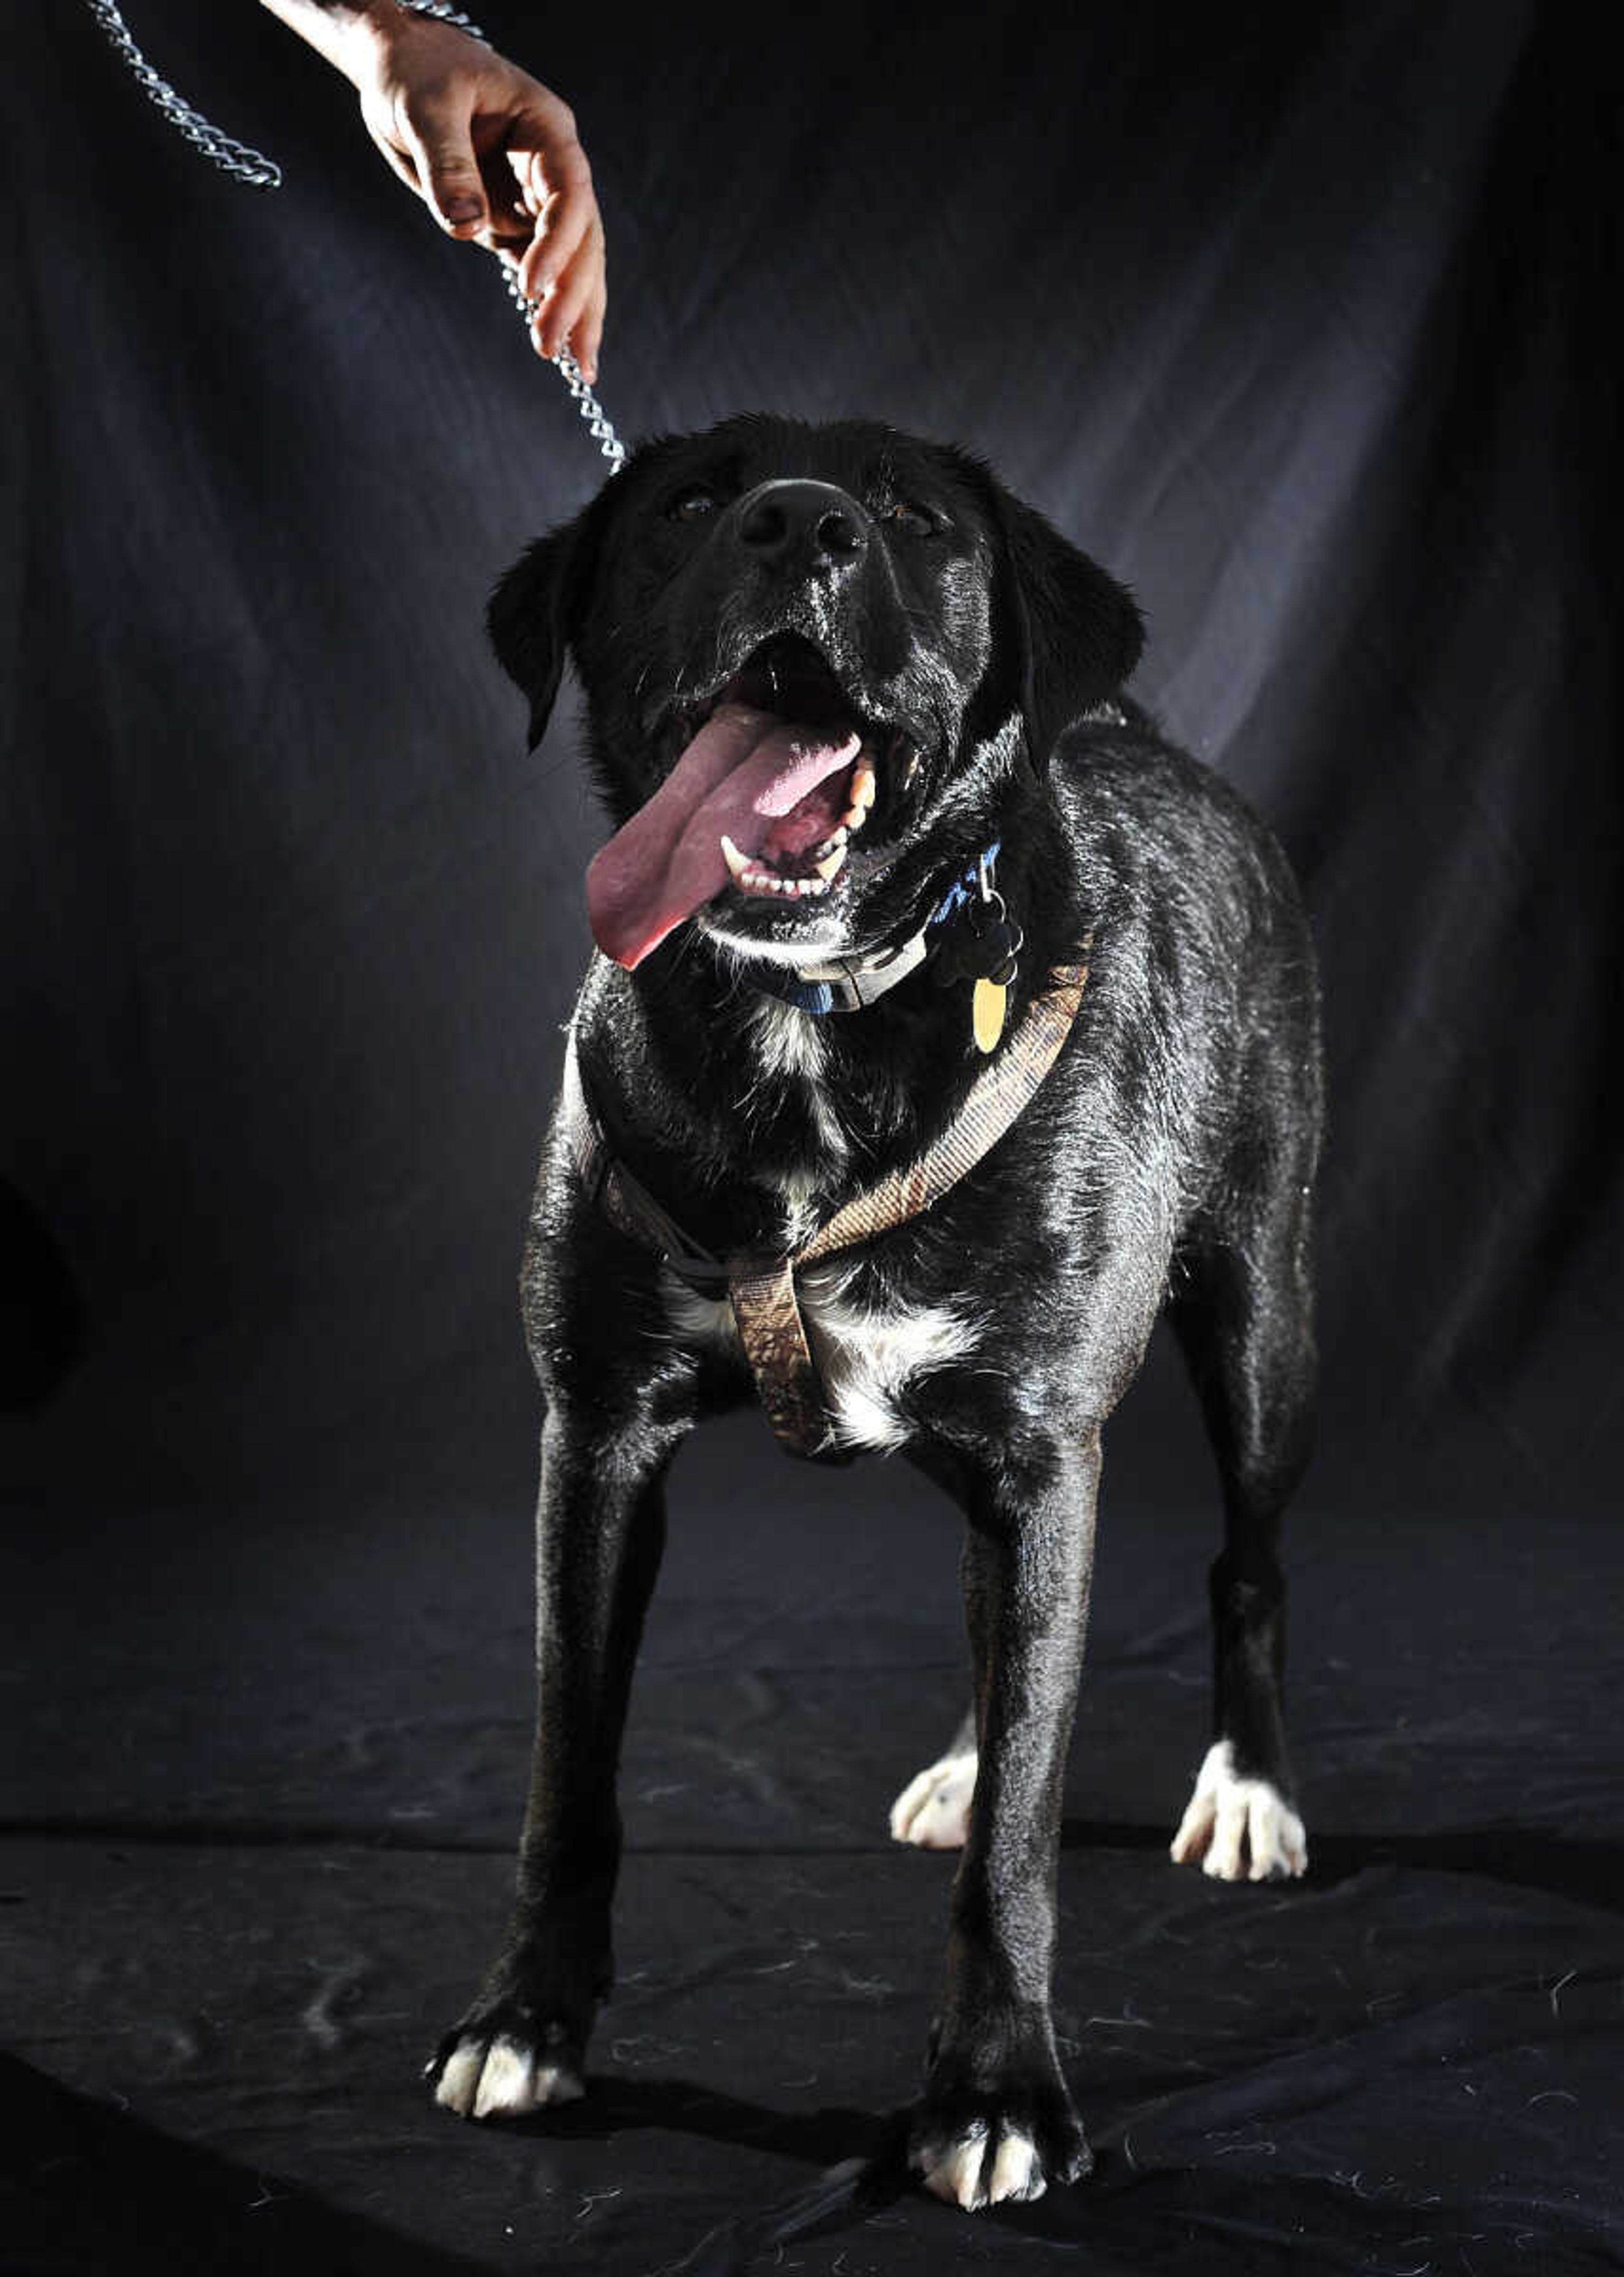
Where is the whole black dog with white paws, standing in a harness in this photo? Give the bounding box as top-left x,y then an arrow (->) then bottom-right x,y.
431,419 -> 1321,2206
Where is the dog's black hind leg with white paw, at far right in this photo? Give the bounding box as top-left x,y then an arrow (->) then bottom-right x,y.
1157,1173 -> 1314,1881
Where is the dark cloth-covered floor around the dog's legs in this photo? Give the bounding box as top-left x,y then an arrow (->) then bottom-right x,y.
0,1366 -> 1624,2277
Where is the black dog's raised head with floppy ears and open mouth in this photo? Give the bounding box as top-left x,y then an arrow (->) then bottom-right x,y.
490,419 -> 1141,965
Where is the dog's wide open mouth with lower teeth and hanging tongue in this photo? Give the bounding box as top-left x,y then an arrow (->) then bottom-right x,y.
588,637 -> 900,970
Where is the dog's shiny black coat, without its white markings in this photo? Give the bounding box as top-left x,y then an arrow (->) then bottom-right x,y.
428,419 -> 1321,2179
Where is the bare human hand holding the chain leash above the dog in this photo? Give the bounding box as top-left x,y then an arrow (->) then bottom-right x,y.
332,5 -> 606,380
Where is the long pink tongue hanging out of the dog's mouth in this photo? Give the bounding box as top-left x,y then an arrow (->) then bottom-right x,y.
585,703 -> 861,970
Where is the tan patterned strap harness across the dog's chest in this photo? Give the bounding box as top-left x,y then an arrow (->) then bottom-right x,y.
565,938 -> 1091,1457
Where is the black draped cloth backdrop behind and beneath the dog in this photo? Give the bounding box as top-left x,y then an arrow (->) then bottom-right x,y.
0,0 -> 1624,2270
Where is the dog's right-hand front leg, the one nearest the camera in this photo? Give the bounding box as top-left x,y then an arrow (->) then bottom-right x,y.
911,1430 -> 1100,2206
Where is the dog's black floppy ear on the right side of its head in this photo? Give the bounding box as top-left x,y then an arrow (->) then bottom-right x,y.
988,481 -> 1146,769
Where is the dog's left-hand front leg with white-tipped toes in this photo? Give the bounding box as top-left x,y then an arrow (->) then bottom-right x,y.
428,1409 -> 674,2120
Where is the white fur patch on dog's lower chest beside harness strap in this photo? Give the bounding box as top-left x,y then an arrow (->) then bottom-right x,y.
665,1259 -> 975,1453
